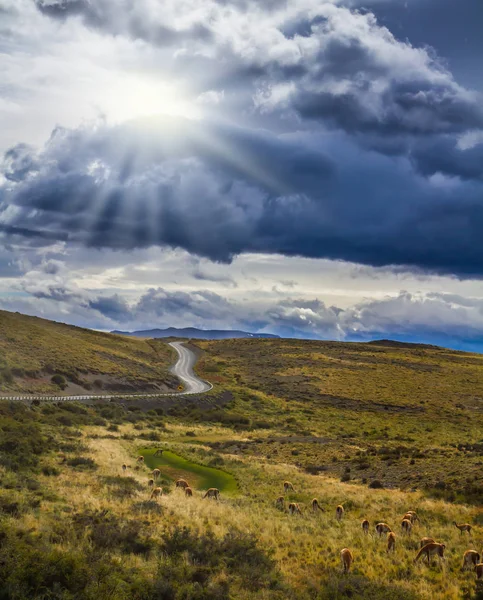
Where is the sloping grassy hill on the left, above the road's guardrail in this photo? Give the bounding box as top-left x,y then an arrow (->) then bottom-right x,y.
0,311 -> 177,394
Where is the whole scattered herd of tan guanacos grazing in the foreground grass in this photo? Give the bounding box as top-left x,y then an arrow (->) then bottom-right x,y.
122,466 -> 483,579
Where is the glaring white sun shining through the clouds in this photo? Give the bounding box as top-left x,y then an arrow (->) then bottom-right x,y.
99,75 -> 199,122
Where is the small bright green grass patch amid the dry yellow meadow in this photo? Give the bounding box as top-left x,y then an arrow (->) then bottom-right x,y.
140,448 -> 238,495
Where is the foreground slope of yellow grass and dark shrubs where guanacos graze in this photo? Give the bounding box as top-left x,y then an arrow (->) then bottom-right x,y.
0,403 -> 483,600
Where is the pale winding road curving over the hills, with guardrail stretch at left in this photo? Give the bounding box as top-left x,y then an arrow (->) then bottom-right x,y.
0,342 -> 213,402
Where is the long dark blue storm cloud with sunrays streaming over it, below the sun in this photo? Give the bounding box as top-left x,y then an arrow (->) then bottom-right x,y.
0,113 -> 483,277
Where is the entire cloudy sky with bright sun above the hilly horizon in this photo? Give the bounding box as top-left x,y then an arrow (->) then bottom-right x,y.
0,0 -> 483,352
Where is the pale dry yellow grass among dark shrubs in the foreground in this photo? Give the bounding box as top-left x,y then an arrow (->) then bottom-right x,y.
20,426 -> 483,600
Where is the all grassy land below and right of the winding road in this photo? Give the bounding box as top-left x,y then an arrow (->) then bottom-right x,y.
0,321 -> 483,600
